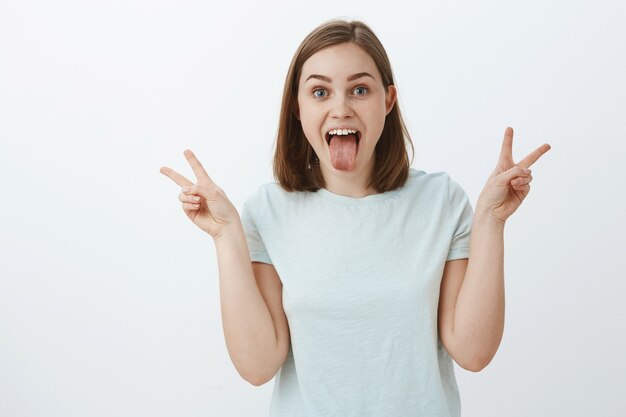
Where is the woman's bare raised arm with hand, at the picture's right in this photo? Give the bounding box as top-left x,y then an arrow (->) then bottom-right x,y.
438,127 -> 550,372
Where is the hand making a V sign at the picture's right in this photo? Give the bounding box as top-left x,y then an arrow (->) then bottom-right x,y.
476,127 -> 551,224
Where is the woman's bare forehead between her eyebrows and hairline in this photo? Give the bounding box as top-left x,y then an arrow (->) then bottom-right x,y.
300,43 -> 382,82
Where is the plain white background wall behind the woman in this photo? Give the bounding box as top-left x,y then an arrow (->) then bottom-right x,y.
0,0 -> 626,417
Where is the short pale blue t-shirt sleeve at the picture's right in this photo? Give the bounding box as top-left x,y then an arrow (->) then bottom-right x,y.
446,177 -> 474,261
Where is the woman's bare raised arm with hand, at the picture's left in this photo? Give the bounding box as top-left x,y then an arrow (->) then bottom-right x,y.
160,150 -> 289,385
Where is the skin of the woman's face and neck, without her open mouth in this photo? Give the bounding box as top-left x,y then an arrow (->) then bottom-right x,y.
296,43 -> 396,197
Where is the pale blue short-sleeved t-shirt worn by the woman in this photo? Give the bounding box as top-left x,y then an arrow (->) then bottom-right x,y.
241,168 -> 473,417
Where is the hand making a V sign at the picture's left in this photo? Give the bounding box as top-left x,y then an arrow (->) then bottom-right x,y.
159,149 -> 239,239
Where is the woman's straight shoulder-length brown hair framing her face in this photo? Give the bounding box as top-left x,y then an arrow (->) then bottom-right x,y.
274,20 -> 415,193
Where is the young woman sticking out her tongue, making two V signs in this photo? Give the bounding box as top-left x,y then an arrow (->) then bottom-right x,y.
161,17 -> 550,417
